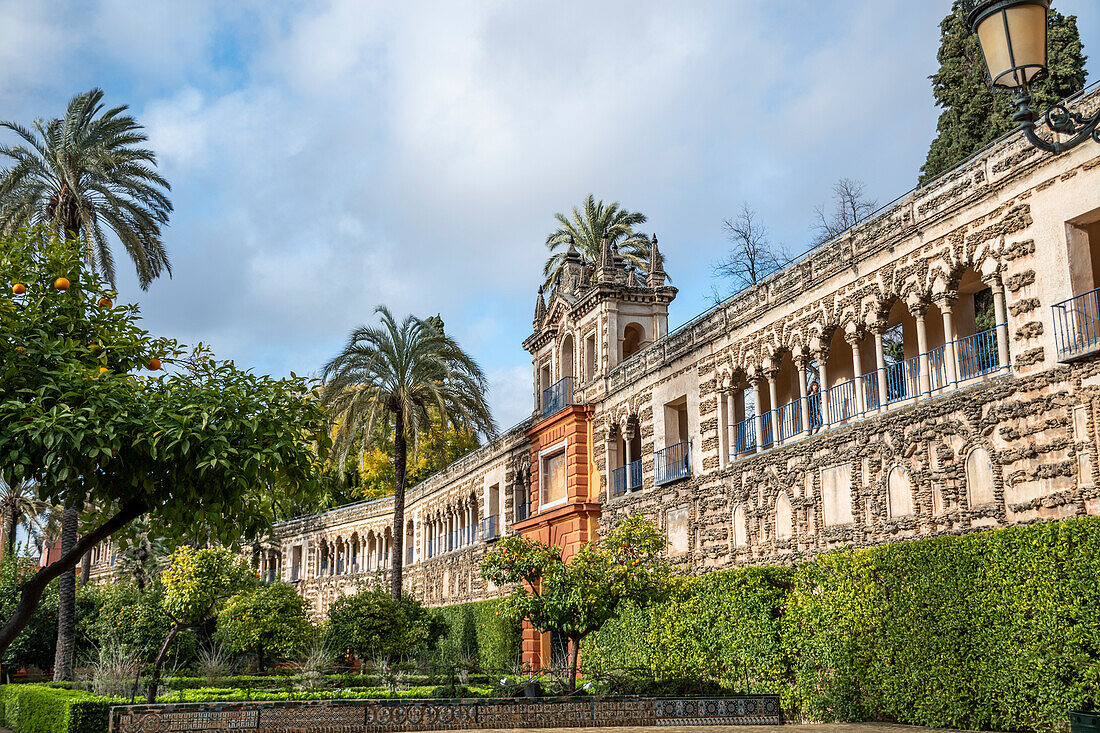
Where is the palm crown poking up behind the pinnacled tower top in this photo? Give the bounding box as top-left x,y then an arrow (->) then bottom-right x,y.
542,194 -> 652,288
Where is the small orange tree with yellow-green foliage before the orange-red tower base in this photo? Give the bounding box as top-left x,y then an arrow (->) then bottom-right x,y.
481,515 -> 670,691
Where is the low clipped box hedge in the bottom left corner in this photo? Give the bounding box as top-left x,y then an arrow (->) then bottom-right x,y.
0,685 -> 117,733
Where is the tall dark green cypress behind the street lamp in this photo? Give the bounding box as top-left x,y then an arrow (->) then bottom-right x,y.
921,0 -> 1086,184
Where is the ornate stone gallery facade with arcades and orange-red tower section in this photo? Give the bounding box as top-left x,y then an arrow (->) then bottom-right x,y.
88,91 -> 1100,666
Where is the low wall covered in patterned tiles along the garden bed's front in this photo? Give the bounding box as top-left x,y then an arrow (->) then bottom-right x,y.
111,696 -> 780,733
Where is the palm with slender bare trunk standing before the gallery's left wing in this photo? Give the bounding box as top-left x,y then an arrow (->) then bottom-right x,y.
321,306 -> 496,600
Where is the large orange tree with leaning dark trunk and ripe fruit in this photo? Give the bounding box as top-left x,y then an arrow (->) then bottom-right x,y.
0,231 -> 327,652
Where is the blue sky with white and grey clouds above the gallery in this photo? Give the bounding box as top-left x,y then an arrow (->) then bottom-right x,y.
0,0 -> 1100,427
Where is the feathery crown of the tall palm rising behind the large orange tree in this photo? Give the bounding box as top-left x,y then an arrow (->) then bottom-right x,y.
0,89 -> 172,289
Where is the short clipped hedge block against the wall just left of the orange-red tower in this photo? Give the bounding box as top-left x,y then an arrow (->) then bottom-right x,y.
436,600 -> 523,670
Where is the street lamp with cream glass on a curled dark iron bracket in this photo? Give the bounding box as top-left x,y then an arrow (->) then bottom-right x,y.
968,0 -> 1100,153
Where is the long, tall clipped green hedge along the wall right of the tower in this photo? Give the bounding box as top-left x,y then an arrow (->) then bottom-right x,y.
583,517 -> 1100,731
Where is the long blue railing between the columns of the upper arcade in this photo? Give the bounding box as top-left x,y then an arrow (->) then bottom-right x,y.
727,323 -> 1007,460
